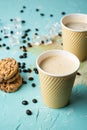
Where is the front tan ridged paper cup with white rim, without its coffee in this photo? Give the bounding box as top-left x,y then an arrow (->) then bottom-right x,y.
36,50 -> 80,108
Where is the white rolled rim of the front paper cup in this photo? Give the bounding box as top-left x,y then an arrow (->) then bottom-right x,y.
36,49 -> 80,77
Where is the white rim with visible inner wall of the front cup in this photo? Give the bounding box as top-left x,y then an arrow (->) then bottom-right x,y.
36,50 -> 80,77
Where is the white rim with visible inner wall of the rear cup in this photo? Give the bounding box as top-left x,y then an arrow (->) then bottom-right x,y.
61,13 -> 87,32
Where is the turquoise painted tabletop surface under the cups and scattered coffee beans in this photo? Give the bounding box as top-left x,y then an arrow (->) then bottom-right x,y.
0,0 -> 87,130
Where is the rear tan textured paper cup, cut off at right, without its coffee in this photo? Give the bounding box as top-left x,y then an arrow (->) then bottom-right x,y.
61,14 -> 87,61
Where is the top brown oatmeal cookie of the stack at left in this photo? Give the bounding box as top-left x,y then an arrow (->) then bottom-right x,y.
0,58 -> 18,82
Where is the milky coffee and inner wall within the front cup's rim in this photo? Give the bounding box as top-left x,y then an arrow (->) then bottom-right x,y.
39,50 -> 77,76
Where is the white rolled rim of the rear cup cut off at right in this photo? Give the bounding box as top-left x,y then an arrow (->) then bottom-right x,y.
60,13 -> 87,32
